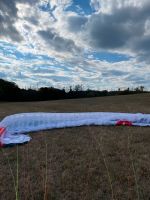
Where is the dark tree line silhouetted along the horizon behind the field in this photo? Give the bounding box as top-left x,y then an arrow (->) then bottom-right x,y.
0,79 -> 148,101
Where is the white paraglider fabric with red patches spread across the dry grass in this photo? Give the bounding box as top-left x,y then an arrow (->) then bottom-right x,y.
0,112 -> 150,146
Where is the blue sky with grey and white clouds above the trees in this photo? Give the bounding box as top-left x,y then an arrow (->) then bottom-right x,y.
0,0 -> 150,89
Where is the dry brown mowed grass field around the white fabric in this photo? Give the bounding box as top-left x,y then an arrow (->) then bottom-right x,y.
0,94 -> 150,200
